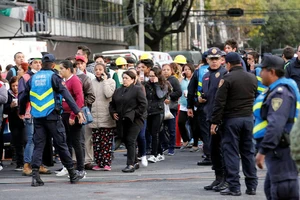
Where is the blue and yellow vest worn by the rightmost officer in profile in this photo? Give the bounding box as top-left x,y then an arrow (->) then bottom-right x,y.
253,78 -> 300,139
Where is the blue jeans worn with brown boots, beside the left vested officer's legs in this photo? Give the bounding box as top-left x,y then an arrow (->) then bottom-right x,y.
24,118 -> 34,163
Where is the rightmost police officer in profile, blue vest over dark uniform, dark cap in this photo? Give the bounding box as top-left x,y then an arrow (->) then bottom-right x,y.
253,55 -> 300,200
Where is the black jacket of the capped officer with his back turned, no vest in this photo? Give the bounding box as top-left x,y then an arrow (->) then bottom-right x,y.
212,66 -> 257,124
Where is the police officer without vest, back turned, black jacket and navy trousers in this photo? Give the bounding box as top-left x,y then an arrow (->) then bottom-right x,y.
210,52 -> 257,196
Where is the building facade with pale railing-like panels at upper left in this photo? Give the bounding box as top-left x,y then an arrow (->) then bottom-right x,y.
0,0 -> 127,59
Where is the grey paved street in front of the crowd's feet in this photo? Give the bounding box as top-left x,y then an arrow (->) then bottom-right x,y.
0,150 -> 265,200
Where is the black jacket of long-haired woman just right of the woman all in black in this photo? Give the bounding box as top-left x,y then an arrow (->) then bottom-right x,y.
145,81 -> 168,115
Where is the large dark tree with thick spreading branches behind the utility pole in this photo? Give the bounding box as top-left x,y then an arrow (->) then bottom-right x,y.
127,0 -> 194,51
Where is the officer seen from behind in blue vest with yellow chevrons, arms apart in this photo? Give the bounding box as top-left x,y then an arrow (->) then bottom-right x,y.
19,54 -> 84,186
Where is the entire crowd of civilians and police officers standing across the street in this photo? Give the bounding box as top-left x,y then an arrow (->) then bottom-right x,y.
0,39 -> 300,199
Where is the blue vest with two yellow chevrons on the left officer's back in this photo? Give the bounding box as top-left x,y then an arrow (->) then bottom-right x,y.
30,70 -> 55,118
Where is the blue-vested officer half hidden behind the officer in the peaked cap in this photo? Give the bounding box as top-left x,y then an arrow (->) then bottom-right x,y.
187,52 -> 211,165
